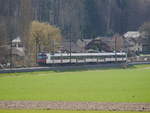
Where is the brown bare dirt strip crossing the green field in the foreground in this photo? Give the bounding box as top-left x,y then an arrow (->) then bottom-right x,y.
0,101 -> 150,111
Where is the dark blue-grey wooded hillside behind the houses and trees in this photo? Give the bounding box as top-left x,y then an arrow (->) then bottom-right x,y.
0,0 -> 150,39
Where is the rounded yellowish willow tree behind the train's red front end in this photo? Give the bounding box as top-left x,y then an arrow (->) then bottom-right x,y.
28,21 -> 62,62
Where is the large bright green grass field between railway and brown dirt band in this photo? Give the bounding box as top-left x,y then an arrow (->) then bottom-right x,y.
0,65 -> 150,102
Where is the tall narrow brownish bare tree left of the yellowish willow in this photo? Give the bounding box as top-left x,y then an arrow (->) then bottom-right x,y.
20,0 -> 32,65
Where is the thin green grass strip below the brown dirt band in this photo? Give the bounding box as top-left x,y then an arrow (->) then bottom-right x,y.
0,110 -> 149,113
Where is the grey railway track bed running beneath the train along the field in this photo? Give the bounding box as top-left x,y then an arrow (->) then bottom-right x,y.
0,62 -> 150,73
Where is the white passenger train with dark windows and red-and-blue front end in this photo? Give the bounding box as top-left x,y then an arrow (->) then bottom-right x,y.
37,52 -> 127,65
